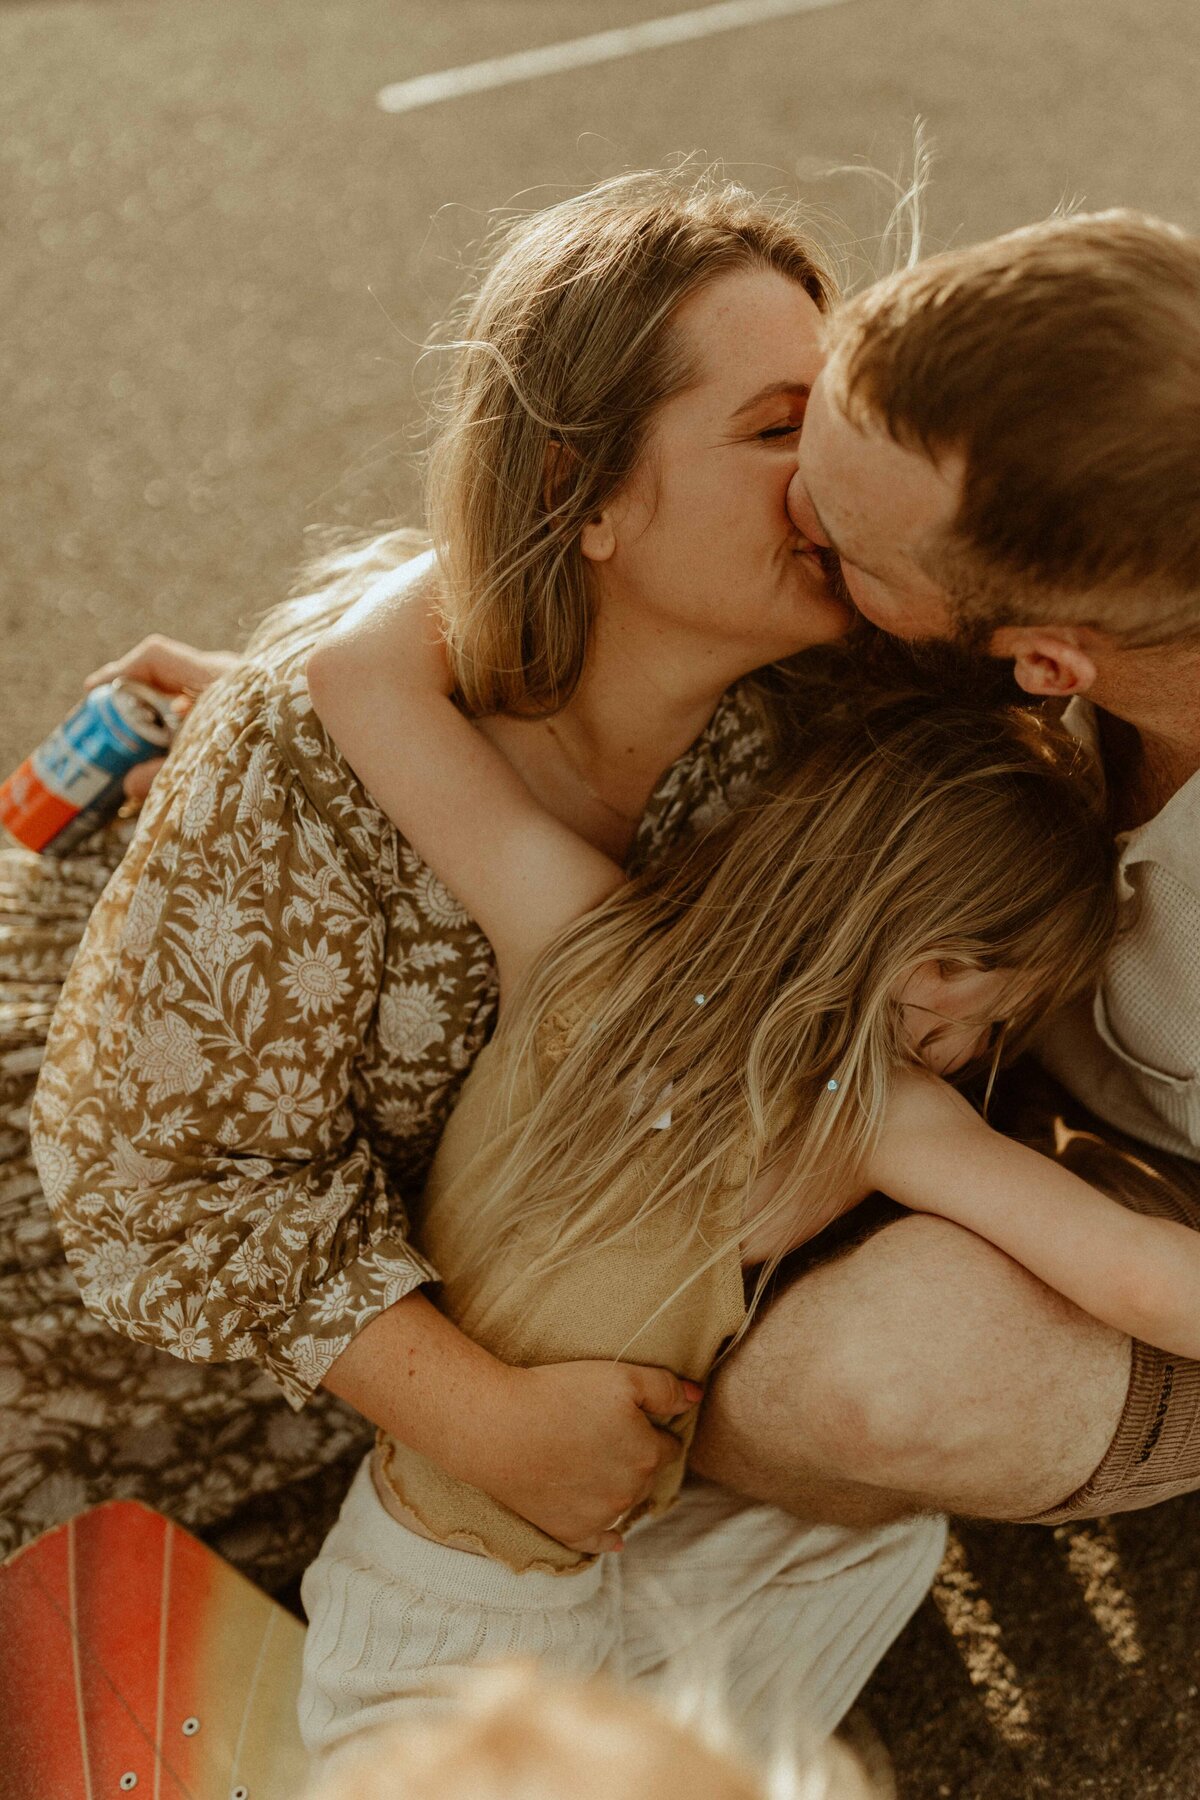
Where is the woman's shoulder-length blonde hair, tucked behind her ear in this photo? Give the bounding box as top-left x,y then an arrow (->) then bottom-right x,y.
254,169 -> 835,702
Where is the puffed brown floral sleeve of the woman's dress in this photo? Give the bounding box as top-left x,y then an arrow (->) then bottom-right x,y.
32,671 -> 434,1406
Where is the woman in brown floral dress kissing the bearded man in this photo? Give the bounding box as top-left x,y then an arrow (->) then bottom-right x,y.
16,178 -> 935,1656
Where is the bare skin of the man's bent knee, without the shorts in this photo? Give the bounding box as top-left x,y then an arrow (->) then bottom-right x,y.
691,1215 -> 1130,1526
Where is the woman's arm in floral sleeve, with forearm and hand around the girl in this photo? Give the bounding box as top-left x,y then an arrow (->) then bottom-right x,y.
32,675 -> 694,1548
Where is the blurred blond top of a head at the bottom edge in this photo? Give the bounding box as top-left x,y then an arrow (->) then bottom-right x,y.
309,1663 -> 873,1800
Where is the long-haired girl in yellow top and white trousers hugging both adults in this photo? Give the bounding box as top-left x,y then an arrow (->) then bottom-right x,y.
302,592 -> 1165,1746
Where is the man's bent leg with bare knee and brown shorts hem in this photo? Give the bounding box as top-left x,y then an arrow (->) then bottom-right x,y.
693,1066 -> 1200,1525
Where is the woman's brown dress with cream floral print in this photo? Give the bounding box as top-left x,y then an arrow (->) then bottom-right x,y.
0,639 -> 766,1586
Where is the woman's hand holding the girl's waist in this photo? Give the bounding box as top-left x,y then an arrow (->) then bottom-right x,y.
468,1363 -> 703,1553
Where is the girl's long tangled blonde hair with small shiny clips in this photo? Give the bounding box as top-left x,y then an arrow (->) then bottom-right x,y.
449,688 -> 1114,1346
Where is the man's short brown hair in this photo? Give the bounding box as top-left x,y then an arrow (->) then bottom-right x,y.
826,211 -> 1200,644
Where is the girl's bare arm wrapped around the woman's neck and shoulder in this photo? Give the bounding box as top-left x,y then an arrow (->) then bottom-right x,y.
308,554 -> 622,986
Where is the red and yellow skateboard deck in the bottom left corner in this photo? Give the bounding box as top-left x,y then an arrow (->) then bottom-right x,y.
0,1499 -> 308,1800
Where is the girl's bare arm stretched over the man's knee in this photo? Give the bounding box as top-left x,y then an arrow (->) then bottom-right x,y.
867,1071 -> 1200,1359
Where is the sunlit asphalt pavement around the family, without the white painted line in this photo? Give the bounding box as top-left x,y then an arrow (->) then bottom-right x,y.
0,0 -> 1200,1800
